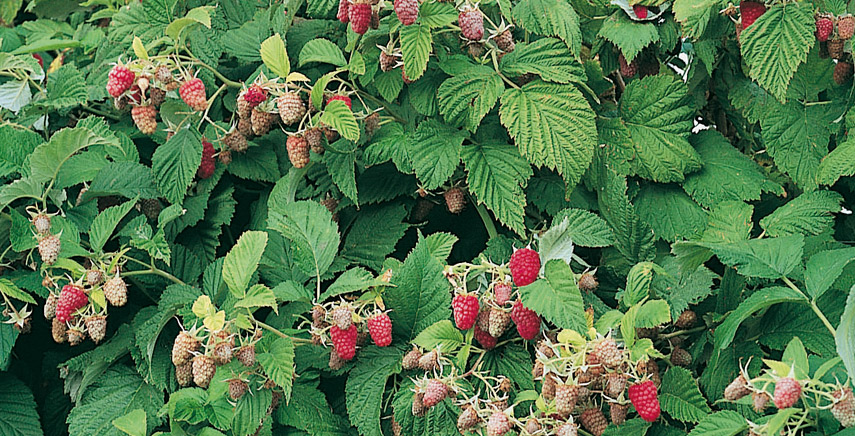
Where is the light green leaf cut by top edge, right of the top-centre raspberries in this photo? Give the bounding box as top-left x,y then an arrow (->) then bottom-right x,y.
513,0 -> 582,57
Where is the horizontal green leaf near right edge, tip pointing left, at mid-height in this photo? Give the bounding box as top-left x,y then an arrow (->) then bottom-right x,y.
760,191 -> 843,236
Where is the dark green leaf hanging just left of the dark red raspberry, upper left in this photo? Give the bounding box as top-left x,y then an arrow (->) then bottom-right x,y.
151,129 -> 202,203
